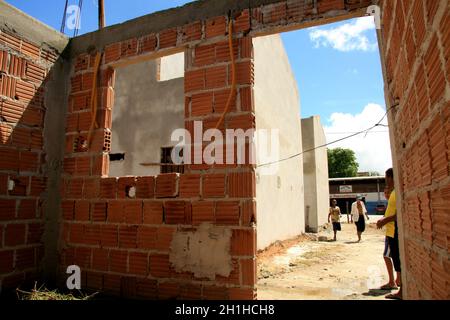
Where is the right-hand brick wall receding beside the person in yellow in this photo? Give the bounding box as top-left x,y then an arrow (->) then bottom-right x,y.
382,0 -> 450,299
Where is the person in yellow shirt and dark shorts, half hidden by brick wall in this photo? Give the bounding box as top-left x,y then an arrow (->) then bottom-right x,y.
377,168 -> 402,299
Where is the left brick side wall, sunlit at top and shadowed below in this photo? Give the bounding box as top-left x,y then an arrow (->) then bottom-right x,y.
0,30 -> 57,292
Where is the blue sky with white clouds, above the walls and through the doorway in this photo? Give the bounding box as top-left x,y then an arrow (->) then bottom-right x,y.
6,0 -> 391,172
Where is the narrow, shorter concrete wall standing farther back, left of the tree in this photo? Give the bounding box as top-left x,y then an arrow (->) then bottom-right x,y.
302,116 -> 329,232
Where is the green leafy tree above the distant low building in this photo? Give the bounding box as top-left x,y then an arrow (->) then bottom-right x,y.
328,148 -> 359,178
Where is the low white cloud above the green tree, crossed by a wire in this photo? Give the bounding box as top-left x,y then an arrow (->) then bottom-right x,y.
324,103 -> 392,174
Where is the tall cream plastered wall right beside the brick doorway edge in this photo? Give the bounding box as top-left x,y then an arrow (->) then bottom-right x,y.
253,35 -> 305,249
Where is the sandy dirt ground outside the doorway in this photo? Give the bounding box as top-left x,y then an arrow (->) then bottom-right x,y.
258,216 -> 398,300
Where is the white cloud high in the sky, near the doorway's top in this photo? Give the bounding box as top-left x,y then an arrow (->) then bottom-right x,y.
309,17 -> 377,52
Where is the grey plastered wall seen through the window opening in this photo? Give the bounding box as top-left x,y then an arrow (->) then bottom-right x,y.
109,56 -> 184,177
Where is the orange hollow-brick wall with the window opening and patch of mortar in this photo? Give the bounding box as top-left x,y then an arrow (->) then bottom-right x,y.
61,11 -> 256,299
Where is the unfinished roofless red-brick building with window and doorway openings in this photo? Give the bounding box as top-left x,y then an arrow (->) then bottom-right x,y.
0,0 -> 450,299
